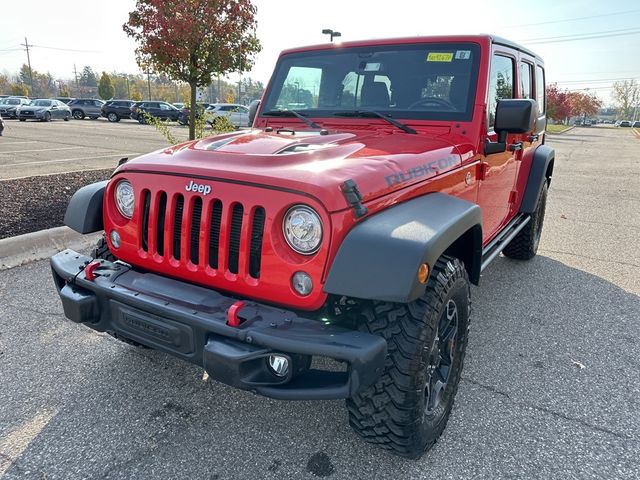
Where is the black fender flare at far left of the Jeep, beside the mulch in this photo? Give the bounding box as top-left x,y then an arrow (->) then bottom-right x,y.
64,180 -> 108,233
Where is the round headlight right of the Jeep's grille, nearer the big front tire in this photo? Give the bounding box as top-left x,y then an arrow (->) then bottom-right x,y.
282,205 -> 322,255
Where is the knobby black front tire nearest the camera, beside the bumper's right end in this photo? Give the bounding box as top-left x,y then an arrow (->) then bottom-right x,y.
347,256 -> 471,458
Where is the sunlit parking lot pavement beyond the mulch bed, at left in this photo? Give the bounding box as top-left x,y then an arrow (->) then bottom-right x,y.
0,118 -> 188,180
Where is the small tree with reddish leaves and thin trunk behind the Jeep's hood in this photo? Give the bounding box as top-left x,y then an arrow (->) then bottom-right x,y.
123,0 -> 261,140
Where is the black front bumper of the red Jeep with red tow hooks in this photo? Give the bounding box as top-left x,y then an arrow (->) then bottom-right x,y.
51,250 -> 387,400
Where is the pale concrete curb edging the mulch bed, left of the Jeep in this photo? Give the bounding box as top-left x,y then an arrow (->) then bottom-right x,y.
0,227 -> 102,270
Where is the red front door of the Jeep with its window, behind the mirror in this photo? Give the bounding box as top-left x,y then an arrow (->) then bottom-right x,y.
478,51 -> 518,242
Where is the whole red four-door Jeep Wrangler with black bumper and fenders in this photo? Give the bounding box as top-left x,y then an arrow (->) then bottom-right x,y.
51,36 -> 554,457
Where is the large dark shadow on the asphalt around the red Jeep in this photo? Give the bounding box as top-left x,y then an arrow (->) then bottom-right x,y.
5,256 -> 640,479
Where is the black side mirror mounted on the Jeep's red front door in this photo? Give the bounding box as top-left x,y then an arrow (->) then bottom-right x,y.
484,98 -> 538,155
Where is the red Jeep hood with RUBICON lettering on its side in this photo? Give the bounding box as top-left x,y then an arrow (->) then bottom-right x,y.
117,129 -> 461,212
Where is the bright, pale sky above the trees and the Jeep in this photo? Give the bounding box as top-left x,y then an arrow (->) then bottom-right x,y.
0,0 -> 640,104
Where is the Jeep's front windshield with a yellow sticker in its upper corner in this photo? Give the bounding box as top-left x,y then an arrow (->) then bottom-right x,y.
261,43 -> 480,121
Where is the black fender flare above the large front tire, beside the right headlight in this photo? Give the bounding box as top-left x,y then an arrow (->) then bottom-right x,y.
324,193 -> 482,303
